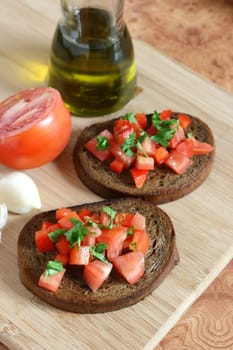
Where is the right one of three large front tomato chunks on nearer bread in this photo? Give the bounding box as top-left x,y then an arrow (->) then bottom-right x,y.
113,252 -> 145,284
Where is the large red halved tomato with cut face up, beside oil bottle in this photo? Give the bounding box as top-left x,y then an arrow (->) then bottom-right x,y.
0,87 -> 71,169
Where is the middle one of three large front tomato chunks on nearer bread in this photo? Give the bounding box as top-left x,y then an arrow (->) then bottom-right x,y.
83,260 -> 113,292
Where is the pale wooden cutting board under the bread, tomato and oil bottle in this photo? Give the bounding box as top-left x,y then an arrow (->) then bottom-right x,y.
0,0 -> 233,350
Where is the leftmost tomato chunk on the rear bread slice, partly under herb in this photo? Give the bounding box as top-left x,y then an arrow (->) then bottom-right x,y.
85,130 -> 113,162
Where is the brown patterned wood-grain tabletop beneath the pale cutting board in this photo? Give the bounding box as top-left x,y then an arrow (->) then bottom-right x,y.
125,0 -> 233,350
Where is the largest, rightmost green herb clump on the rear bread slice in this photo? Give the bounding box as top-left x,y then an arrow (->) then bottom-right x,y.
151,111 -> 179,147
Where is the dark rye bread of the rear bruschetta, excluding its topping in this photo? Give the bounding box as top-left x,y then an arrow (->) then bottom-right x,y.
73,113 -> 214,204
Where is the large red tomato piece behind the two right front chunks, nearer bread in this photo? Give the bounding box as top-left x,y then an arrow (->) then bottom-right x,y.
96,226 -> 127,261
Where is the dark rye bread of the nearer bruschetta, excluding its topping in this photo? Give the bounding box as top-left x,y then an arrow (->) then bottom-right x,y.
18,198 -> 179,313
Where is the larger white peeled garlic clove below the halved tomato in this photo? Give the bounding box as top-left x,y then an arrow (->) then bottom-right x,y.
0,171 -> 41,214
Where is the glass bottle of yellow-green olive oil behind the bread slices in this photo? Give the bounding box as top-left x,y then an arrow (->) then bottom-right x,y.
49,0 -> 136,116
